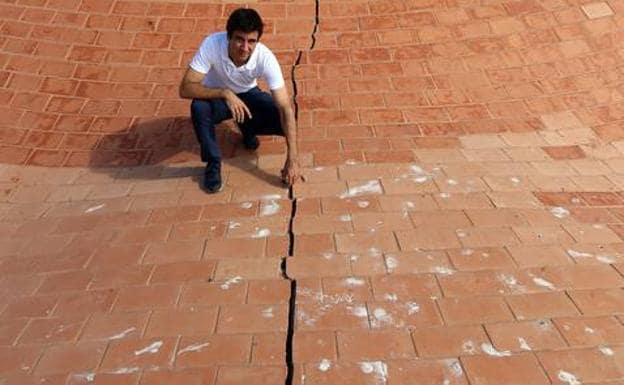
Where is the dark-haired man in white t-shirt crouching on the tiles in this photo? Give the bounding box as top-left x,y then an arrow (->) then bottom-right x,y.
180,8 -> 300,193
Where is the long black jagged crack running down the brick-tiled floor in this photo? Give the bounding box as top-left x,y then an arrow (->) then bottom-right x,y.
280,0 -> 320,385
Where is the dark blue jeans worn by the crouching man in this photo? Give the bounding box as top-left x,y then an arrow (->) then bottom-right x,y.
191,87 -> 284,162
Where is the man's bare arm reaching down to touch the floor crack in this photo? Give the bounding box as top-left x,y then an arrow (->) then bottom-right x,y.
271,87 -> 301,185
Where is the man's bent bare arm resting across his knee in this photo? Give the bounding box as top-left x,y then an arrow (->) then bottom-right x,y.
179,67 -> 251,123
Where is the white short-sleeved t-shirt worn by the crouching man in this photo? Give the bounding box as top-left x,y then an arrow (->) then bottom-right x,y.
189,32 -> 284,94
